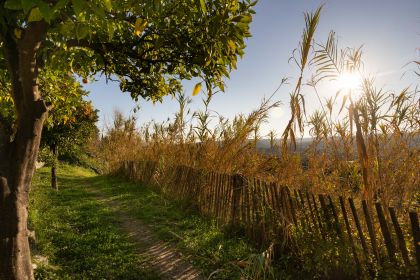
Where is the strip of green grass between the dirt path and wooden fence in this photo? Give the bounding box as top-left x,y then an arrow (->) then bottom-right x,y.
83,176 -> 256,279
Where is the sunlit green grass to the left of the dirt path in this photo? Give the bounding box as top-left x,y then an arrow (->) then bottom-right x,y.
29,165 -> 159,279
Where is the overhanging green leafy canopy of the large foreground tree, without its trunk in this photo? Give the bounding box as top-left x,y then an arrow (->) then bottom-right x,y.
1,0 -> 256,101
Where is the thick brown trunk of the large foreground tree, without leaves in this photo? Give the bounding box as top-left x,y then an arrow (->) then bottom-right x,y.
0,21 -> 48,280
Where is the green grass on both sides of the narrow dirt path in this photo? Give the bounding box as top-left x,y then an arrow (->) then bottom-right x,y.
30,165 -> 256,279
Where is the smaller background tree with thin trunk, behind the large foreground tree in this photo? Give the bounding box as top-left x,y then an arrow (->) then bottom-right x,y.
0,61 -> 98,189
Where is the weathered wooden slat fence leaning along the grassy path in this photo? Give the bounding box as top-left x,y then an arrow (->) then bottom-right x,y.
121,162 -> 420,278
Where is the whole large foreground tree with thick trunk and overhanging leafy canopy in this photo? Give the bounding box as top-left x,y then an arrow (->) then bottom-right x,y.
0,0 -> 255,279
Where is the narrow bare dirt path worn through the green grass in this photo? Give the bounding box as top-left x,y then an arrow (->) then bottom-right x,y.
88,188 -> 207,280
